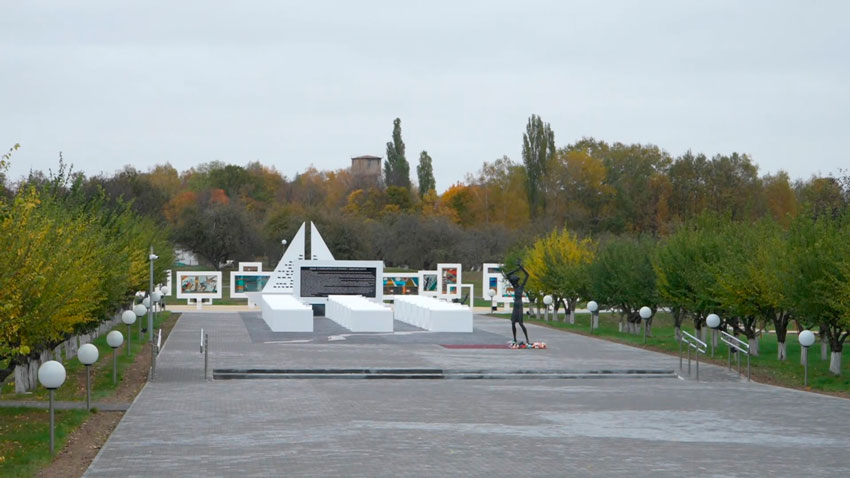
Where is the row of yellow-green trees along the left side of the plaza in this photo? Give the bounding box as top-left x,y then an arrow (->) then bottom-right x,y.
0,155 -> 174,382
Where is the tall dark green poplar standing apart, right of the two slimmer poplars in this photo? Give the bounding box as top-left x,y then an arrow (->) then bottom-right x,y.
522,115 -> 555,217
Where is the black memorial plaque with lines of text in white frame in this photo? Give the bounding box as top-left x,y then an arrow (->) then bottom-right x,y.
301,266 -> 378,297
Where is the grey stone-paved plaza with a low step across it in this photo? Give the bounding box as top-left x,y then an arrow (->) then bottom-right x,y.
85,312 -> 850,478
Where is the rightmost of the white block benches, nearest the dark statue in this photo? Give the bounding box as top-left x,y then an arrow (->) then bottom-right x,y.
394,295 -> 472,332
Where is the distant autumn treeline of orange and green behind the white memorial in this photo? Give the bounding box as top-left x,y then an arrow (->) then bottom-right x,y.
4,116 -> 850,268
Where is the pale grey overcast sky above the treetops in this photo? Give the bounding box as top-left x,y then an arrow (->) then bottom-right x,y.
0,0 -> 850,191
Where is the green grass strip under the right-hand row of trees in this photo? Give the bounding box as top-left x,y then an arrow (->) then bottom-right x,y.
495,312 -> 850,397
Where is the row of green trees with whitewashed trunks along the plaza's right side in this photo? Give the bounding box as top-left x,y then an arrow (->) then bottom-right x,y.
506,211 -> 850,375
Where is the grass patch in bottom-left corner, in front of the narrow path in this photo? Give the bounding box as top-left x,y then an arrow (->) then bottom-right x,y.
0,408 -> 89,477
